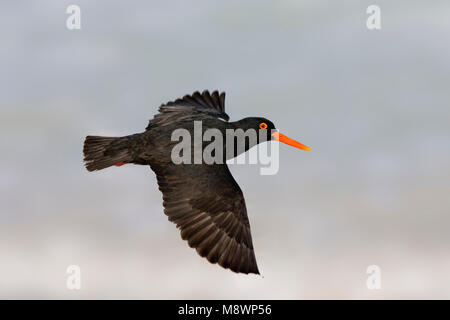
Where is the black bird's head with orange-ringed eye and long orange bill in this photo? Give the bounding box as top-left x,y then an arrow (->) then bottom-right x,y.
239,117 -> 311,151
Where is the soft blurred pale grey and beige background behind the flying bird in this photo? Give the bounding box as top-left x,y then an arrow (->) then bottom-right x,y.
0,0 -> 450,299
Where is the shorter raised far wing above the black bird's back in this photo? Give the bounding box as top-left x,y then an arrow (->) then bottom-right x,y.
146,90 -> 230,130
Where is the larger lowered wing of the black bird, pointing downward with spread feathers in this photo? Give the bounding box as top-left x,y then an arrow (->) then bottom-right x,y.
151,164 -> 259,274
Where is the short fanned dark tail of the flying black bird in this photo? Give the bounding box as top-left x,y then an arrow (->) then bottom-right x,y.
83,136 -> 133,171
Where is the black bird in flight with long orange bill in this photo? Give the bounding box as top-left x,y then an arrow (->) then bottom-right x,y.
83,91 -> 309,274
